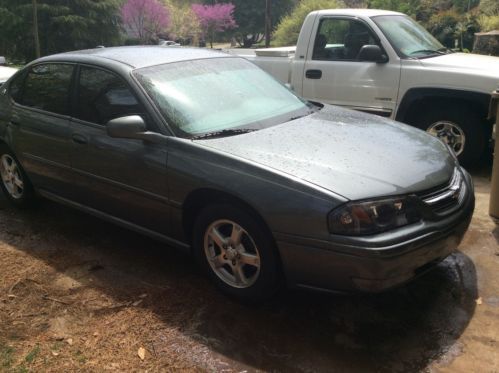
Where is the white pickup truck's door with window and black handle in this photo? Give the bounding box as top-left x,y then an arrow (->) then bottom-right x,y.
302,17 -> 401,117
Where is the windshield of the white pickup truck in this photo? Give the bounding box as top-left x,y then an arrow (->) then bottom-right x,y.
372,16 -> 451,58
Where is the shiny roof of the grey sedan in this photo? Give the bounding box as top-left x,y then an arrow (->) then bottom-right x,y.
37,45 -> 230,68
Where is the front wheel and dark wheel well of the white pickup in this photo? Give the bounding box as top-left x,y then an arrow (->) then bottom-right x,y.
416,105 -> 486,166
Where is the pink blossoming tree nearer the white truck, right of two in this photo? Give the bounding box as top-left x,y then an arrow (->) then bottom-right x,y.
192,3 -> 237,48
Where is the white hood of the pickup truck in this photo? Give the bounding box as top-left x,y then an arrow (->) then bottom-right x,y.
420,53 -> 499,80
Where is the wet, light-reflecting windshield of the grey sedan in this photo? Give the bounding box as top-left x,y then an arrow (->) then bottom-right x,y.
134,58 -> 311,138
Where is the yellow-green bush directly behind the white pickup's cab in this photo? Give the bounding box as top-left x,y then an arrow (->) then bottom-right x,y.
274,0 -> 345,46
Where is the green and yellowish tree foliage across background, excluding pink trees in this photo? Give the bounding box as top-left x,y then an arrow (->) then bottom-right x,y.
0,0 -> 499,63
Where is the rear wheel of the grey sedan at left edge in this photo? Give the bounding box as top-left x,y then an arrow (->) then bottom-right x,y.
0,145 -> 35,207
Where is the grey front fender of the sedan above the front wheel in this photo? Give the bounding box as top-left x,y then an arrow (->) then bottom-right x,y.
164,138 -> 345,240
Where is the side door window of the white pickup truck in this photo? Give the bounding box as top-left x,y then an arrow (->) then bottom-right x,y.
312,18 -> 379,61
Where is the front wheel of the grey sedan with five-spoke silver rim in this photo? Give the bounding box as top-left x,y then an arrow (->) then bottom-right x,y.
193,204 -> 281,303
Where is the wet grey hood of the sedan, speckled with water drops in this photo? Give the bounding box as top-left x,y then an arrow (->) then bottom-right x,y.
195,105 -> 455,200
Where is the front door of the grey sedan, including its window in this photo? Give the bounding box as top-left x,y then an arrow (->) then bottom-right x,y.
70,65 -> 169,234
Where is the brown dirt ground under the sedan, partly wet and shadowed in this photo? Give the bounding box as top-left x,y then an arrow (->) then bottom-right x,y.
0,166 -> 499,372
